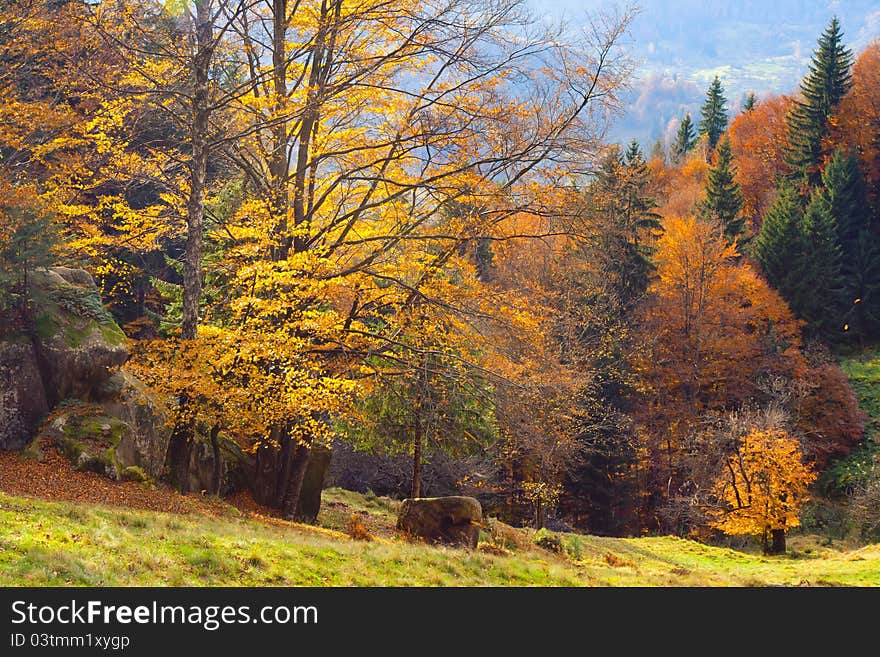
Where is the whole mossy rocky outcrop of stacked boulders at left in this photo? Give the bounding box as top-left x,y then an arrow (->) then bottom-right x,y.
0,267 -> 171,479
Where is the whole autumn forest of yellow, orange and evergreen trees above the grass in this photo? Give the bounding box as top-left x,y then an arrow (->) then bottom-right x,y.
0,0 -> 880,554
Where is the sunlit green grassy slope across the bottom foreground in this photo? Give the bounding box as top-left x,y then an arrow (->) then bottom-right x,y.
0,489 -> 880,586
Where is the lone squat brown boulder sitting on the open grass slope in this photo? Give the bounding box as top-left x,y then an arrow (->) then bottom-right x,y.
397,495 -> 483,549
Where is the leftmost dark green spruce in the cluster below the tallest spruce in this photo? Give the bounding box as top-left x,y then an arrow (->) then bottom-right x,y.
752,183 -> 807,303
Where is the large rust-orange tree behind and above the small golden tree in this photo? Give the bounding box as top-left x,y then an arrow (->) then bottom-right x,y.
632,217 -> 803,524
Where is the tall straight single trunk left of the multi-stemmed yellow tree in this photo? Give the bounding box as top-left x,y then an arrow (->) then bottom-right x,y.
181,0 -> 214,340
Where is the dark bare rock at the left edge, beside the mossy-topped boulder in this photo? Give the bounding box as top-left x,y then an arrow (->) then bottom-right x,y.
0,339 -> 49,451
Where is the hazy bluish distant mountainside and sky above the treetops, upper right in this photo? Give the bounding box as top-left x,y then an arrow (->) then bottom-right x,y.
527,0 -> 880,147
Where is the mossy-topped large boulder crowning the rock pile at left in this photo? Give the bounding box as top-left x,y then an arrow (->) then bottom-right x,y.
30,267 -> 128,405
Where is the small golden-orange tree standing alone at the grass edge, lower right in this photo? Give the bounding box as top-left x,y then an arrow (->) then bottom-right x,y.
711,430 -> 816,554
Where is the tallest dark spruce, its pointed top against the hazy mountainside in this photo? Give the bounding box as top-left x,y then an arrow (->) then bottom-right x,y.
785,17 -> 853,186
